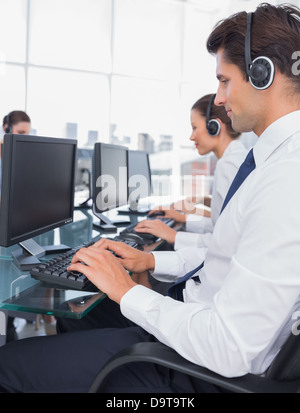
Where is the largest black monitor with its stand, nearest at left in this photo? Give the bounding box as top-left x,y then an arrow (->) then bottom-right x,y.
0,134 -> 77,270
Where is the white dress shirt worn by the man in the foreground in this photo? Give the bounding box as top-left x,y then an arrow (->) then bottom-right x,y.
121,111 -> 300,377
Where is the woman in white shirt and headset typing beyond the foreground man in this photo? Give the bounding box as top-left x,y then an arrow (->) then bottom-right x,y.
135,94 -> 247,254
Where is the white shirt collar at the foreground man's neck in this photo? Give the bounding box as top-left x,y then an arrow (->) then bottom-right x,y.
253,110 -> 300,166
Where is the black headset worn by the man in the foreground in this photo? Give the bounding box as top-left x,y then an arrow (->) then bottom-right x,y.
245,13 -> 275,90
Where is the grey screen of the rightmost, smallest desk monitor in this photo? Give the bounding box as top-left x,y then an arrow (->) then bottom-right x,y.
128,150 -> 152,204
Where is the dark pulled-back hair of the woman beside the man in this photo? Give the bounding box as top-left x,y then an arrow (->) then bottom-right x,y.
191,94 -> 241,139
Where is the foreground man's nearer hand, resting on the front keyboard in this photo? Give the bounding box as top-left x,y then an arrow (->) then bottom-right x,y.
68,246 -> 136,304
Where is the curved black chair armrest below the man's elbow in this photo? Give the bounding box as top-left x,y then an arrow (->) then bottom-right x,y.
89,342 -> 300,393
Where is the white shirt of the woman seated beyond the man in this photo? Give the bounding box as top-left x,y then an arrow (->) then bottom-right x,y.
174,140 -> 247,250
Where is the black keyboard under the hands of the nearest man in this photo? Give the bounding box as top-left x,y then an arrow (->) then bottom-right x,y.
30,233 -> 139,292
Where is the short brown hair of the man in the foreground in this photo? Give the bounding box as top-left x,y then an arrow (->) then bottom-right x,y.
206,3 -> 300,92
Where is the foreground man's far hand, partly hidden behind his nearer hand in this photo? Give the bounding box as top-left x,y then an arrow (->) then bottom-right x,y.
91,238 -> 155,273
